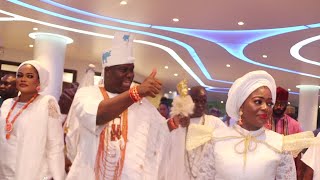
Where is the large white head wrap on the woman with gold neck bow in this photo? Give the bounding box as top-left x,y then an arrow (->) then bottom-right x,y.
226,70 -> 277,119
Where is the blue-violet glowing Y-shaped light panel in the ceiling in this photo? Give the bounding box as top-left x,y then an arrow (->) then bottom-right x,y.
152,26 -> 320,79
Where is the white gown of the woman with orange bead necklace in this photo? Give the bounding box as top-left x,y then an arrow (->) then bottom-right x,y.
0,95 -> 65,180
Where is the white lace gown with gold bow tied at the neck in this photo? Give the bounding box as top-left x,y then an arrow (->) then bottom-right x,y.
197,125 -> 296,180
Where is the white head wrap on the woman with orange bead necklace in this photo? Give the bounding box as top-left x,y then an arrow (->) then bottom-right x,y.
18,60 -> 49,92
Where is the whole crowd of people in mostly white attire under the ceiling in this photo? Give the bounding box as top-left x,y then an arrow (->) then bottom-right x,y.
0,32 -> 320,180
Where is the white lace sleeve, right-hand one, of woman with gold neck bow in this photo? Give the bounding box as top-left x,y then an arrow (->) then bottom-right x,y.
276,153 -> 297,180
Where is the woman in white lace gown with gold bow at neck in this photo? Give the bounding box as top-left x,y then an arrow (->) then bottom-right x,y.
192,71 -> 296,180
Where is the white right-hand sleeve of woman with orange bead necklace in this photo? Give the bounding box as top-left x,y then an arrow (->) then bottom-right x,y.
46,99 -> 65,180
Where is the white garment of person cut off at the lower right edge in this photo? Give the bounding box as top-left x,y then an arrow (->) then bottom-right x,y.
301,133 -> 320,180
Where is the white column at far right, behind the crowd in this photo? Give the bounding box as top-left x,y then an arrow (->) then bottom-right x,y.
297,85 -> 320,131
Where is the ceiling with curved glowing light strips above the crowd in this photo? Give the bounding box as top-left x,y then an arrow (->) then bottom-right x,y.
0,0 -> 320,105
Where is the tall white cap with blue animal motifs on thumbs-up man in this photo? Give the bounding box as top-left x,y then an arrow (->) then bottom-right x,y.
102,32 -> 135,68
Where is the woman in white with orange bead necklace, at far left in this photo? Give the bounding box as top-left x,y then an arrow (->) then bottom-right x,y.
0,60 -> 65,180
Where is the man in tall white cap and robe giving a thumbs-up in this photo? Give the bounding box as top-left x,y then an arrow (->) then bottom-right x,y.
67,33 -> 169,180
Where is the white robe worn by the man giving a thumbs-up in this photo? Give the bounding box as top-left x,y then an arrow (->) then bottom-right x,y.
67,86 -> 169,180
